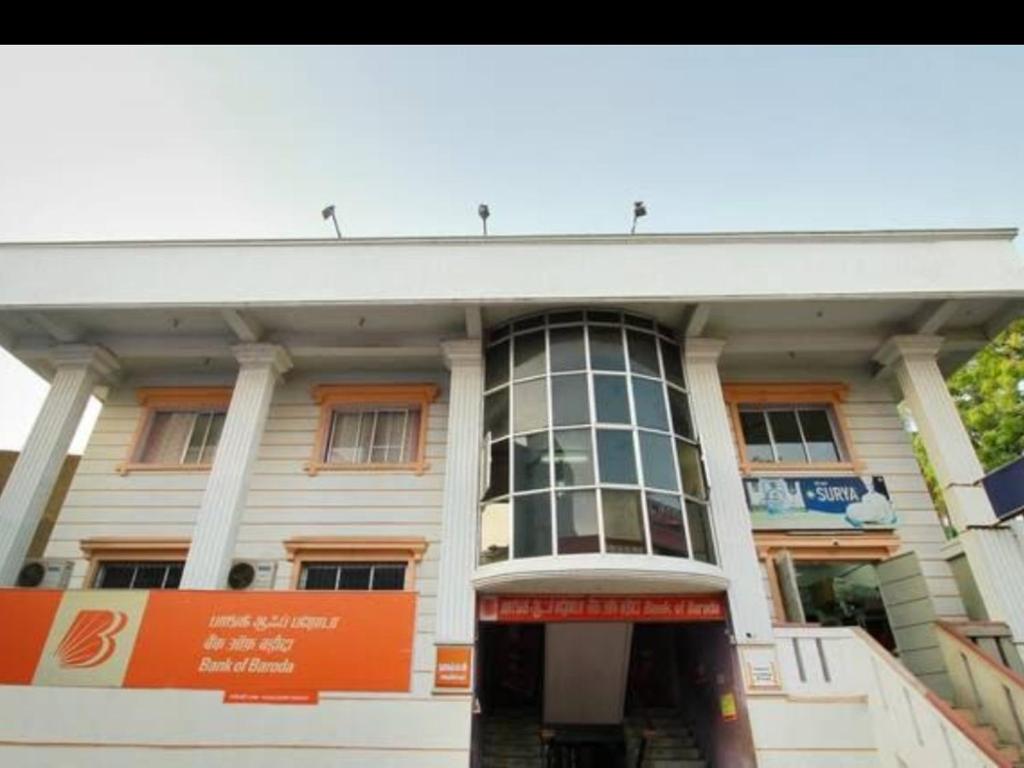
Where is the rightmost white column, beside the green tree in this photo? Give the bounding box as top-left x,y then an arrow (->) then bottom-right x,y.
876,336 -> 1024,645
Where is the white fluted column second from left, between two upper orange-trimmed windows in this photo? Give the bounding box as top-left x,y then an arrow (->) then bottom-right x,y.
181,344 -> 292,590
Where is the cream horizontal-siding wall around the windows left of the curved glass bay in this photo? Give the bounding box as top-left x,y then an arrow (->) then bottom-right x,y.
46,369 -> 447,696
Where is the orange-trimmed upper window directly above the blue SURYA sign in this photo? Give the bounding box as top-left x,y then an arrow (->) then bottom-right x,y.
724,383 -> 857,473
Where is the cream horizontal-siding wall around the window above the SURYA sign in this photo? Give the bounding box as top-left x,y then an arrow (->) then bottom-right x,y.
722,367 -> 966,621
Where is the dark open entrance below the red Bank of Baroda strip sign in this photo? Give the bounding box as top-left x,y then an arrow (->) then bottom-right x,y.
474,606 -> 754,768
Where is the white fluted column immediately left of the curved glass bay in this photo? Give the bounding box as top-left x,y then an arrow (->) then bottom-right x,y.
434,339 -> 483,645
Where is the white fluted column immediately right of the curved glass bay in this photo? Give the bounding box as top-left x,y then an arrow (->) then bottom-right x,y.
684,339 -> 772,644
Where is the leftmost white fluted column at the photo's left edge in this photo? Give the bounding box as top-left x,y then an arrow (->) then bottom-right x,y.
0,344 -> 118,587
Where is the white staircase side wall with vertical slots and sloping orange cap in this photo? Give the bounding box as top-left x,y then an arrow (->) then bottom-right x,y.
775,627 -> 1012,768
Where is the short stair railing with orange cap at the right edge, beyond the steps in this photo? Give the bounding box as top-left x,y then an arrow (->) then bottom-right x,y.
936,622 -> 1024,745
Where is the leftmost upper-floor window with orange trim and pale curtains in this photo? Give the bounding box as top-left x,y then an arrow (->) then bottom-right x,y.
119,387 -> 231,473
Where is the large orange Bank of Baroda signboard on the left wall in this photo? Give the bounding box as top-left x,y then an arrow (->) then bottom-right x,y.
0,590 -> 416,702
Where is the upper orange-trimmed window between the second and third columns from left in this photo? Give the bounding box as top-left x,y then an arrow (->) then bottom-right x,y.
307,384 -> 438,474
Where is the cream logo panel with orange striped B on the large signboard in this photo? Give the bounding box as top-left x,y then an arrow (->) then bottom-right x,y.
33,590 -> 148,686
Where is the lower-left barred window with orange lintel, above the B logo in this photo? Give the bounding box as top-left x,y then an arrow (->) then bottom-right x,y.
81,539 -> 188,590
